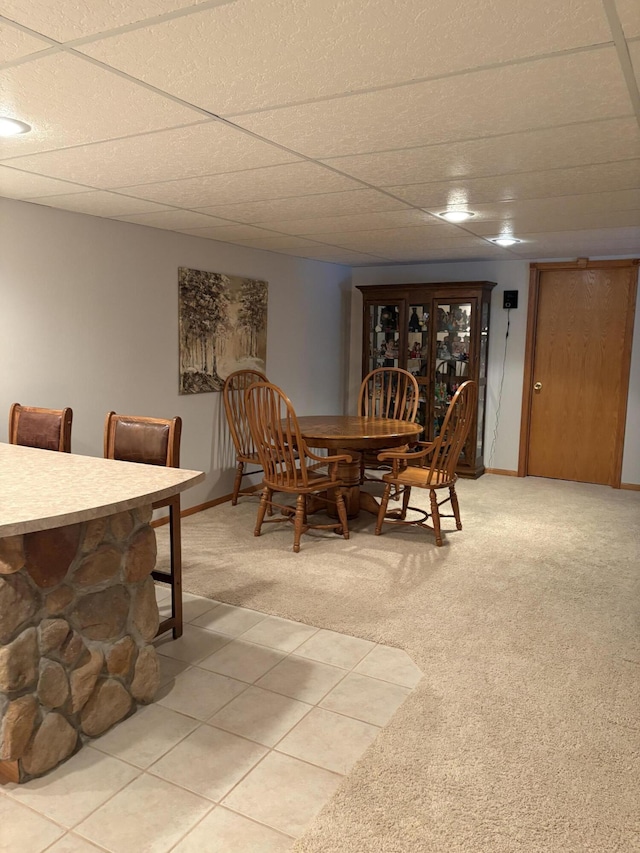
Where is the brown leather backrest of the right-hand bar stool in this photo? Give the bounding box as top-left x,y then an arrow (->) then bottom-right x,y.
104,412 -> 182,468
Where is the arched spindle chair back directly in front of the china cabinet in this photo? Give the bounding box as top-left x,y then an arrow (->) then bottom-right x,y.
358,367 -> 420,423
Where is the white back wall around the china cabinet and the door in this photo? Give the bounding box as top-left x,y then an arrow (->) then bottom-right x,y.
349,260 -> 640,483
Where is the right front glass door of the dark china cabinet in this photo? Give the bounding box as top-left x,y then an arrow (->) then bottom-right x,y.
433,300 -> 475,452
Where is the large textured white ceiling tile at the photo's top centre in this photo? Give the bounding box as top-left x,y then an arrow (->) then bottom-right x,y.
80,0 -> 611,114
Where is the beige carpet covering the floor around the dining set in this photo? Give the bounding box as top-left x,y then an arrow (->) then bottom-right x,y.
158,475 -> 640,853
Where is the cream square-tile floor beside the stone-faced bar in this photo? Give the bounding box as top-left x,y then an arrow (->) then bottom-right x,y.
0,587 -> 421,853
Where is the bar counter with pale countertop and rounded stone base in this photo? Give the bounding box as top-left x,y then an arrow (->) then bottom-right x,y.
0,444 -> 204,782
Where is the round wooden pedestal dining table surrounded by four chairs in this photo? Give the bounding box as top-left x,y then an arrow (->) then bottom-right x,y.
298,415 -> 423,518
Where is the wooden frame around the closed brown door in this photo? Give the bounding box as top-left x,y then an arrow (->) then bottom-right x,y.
518,258 -> 640,489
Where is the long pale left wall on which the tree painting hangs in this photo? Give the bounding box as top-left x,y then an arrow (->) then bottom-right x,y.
0,199 -> 350,507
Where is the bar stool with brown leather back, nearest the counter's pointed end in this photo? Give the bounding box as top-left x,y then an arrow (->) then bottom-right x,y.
104,412 -> 182,640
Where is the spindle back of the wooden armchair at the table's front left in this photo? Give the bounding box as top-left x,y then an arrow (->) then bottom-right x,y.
246,382 -> 310,491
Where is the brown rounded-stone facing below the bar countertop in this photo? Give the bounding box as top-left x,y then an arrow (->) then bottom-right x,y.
0,506 -> 159,782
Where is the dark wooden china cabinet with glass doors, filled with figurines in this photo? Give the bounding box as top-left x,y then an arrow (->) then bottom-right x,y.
358,281 -> 495,477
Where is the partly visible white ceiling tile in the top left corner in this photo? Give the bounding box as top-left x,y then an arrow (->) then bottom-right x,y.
2,0 -> 230,41
